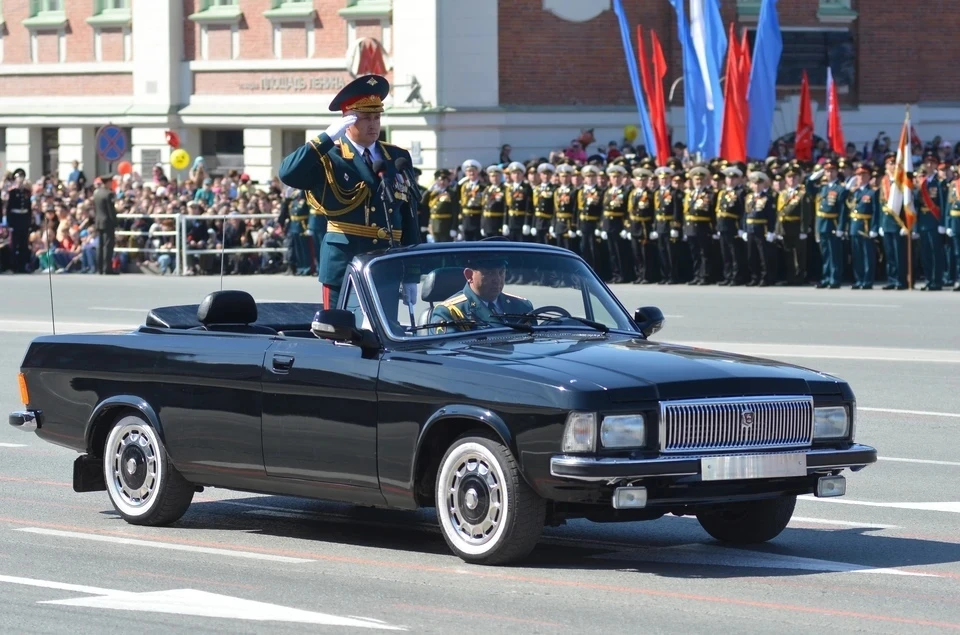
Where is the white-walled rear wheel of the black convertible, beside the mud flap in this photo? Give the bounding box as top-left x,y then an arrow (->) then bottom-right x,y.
103,414 -> 195,525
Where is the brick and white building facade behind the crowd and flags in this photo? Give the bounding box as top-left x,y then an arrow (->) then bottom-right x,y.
0,0 -> 960,181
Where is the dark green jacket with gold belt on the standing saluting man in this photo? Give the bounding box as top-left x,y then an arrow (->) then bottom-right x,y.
279,132 -> 420,289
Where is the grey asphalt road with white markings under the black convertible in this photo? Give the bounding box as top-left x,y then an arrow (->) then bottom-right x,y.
0,275 -> 960,634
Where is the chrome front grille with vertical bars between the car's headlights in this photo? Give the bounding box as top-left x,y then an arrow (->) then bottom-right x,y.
660,396 -> 813,452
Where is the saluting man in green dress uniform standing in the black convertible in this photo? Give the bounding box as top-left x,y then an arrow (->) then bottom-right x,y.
279,75 -> 420,309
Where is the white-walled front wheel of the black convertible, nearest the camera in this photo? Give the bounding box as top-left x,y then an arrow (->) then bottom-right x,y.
436,436 -> 546,565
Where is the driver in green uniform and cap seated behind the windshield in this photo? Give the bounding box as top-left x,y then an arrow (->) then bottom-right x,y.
430,256 -> 533,334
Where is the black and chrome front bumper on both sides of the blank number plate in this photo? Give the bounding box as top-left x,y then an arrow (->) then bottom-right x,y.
550,444 -> 877,481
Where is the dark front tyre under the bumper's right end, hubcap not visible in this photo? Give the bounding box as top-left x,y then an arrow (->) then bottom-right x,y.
697,496 -> 797,545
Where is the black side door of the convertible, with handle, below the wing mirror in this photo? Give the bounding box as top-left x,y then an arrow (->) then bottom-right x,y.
262,279 -> 380,488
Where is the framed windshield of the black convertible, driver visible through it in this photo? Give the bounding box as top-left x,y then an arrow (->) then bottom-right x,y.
367,246 -> 636,339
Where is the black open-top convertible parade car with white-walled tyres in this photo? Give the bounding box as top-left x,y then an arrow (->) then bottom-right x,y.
9,240 -> 877,564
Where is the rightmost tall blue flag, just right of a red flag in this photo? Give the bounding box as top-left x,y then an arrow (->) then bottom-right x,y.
747,0 -> 783,159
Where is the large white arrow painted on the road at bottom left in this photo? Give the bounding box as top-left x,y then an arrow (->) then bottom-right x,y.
0,575 -> 407,631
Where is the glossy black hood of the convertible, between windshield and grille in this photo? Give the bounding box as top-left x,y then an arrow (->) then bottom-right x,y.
416,333 -> 842,401
